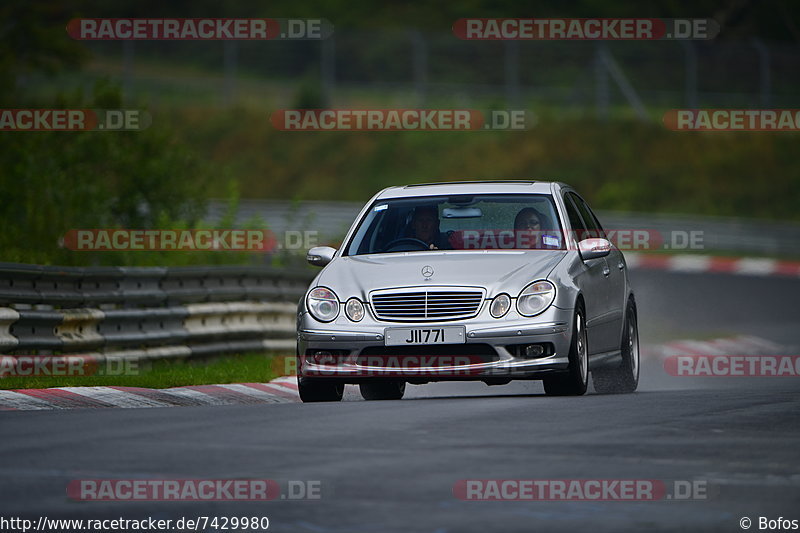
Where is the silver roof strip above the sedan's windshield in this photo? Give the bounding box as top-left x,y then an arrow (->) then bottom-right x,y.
376,180 -> 553,199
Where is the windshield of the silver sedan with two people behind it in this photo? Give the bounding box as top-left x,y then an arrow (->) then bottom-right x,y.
344,194 -> 564,255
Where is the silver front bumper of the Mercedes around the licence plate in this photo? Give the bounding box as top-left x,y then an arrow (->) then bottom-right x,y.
297,306 -> 573,383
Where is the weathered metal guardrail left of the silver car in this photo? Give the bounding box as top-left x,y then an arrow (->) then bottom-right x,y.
0,263 -> 313,366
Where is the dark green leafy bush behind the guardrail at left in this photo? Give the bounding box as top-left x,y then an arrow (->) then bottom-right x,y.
0,84 -> 274,265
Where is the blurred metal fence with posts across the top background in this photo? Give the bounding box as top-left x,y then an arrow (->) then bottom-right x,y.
64,28 -> 800,117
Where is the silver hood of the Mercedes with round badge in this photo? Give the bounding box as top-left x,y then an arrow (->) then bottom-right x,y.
317,250 -> 566,299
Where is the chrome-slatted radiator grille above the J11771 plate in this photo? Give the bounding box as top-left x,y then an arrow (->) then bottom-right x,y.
372,290 -> 483,320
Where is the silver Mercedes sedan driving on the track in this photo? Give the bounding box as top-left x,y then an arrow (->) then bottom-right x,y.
297,181 -> 639,402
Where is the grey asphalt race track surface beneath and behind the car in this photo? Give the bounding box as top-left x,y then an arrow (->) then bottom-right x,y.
0,271 -> 800,533
